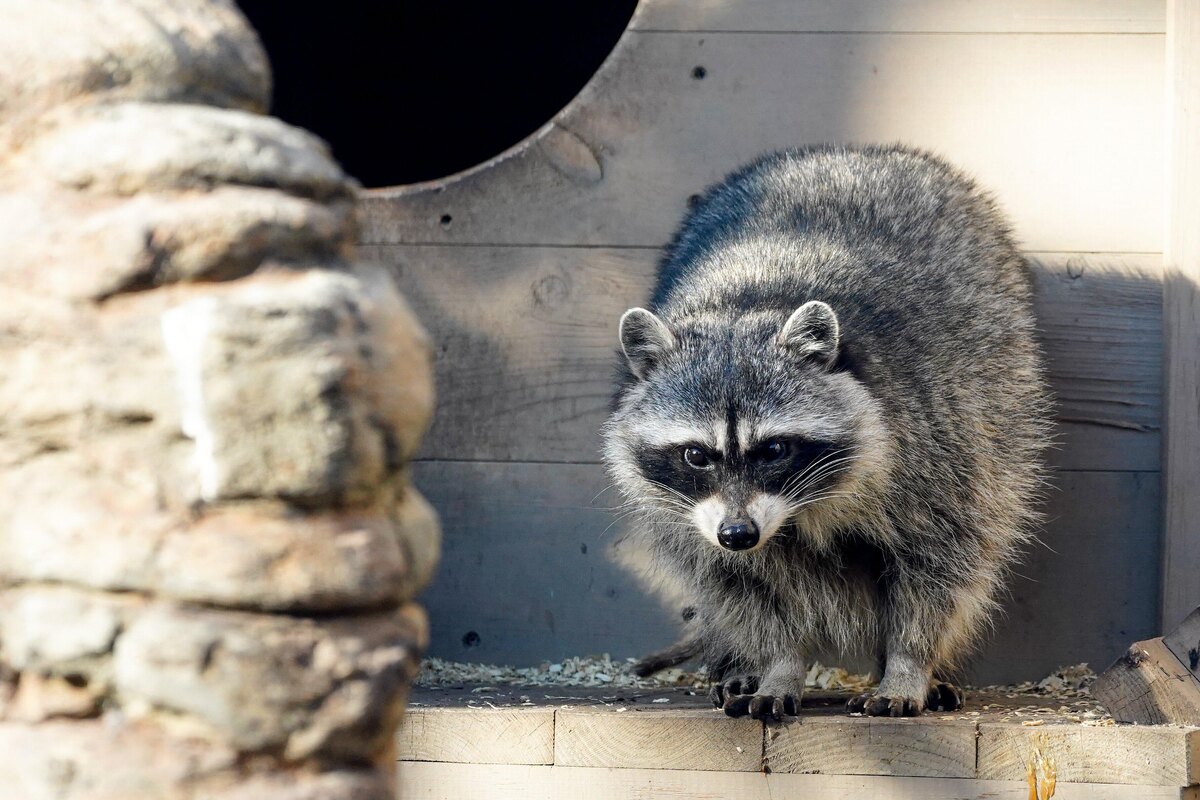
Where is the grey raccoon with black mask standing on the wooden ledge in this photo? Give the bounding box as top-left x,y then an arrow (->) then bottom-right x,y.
602,145 -> 1049,720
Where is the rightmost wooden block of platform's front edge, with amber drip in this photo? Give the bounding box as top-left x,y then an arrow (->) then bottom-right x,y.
978,723 -> 1200,787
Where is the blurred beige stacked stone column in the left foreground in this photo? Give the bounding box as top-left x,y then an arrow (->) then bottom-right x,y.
0,0 -> 438,800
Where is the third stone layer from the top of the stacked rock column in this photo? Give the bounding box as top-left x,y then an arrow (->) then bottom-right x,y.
0,187 -> 354,300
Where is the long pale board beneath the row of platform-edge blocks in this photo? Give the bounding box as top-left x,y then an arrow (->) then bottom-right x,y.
398,762 -> 1192,800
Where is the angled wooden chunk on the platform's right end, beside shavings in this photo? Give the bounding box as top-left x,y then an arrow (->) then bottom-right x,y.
1092,638 -> 1200,724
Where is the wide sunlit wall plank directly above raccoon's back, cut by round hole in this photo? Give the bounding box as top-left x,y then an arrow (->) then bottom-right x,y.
360,32 -> 1164,252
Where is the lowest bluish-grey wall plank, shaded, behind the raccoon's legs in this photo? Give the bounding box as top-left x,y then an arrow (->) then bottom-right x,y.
414,462 -> 1158,684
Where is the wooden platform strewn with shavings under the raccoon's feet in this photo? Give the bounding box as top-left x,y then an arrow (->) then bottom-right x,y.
397,686 -> 1200,800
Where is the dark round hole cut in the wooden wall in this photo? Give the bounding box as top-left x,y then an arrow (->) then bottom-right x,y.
238,0 -> 637,187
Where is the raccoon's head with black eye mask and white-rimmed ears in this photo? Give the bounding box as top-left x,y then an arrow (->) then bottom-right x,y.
605,301 -> 883,552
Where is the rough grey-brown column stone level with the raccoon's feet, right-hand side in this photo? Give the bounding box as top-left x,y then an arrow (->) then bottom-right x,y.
114,606 -> 425,762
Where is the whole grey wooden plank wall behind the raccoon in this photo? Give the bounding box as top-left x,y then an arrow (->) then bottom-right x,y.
361,0 -> 1165,681
